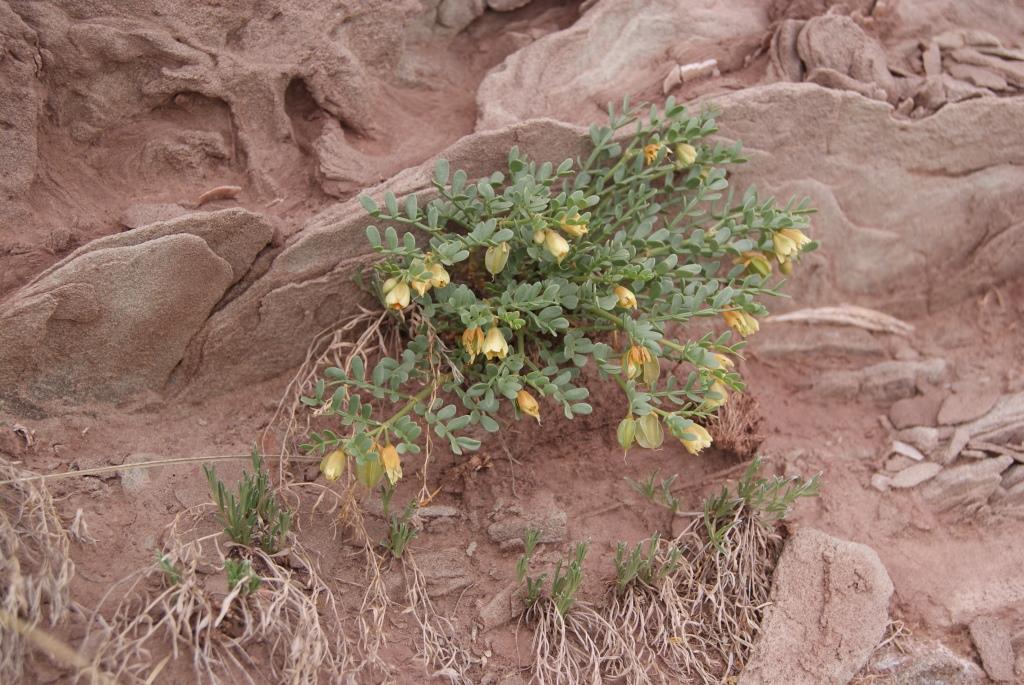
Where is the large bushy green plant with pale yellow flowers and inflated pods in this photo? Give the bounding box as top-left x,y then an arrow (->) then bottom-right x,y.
302,98 -> 814,487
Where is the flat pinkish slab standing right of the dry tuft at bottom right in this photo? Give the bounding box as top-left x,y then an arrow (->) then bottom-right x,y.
738,528 -> 893,685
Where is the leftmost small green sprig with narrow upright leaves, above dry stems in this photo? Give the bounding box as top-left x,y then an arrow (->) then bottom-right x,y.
203,449 -> 292,554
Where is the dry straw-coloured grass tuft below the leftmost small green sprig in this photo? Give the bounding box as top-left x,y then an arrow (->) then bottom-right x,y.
89,507 -> 352,685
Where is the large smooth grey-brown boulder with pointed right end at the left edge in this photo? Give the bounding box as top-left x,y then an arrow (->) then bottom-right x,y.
0,210 -> 271,410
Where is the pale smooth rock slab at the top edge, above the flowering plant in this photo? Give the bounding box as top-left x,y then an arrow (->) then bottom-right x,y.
477,0 -> 768,130
